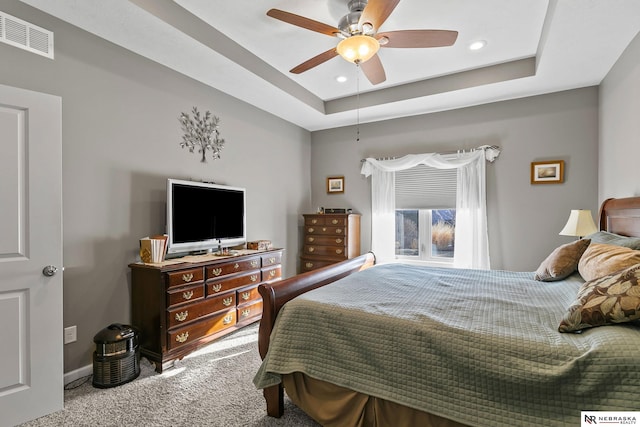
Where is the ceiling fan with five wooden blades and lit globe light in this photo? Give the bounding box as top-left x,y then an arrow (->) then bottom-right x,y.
267,0 -> 458,85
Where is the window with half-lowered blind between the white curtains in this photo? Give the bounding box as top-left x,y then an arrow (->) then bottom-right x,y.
395,165 -> 457,263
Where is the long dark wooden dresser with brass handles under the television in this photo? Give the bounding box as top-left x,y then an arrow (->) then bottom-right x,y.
129,249 -> 283,372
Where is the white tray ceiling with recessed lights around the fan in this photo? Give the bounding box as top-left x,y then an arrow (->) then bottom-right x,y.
17,0 -> 640,131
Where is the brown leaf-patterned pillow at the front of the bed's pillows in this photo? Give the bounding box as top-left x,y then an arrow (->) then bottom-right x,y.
558,264 -> 640,332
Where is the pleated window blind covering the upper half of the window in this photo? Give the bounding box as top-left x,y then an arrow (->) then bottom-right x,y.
396,165 -> 457,209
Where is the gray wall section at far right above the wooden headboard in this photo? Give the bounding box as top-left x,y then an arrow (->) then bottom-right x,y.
598,30 -> 640,201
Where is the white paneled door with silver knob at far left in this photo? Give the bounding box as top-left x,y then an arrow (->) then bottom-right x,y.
0,85 -> 64,426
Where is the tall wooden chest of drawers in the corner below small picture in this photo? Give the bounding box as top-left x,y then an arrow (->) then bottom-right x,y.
300,214 -> 360,272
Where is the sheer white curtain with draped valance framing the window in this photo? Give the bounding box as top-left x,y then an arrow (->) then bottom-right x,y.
361,147 -> 492,270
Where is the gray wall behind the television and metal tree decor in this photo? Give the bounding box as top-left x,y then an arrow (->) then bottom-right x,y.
0,0 -> 311,372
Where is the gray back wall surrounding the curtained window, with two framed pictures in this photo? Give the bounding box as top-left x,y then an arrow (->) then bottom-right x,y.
311,87 -> 598,271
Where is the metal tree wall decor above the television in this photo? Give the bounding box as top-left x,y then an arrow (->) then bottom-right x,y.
178,107 -> 224,163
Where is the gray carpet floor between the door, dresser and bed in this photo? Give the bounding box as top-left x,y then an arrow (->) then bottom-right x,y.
22,324 -> 319,427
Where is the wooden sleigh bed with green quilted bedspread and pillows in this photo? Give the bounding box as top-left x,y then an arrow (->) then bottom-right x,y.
254,197 -> 640,426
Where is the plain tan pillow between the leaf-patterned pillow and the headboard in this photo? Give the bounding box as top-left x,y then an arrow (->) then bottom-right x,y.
578,243 -> 640,281
